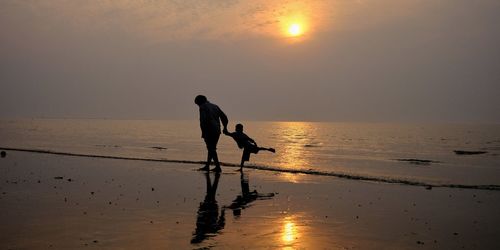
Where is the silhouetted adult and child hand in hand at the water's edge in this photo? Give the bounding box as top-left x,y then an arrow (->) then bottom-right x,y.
194,95 -> 275,172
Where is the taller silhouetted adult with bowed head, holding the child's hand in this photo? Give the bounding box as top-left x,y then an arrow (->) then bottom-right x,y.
194,95 -> 228,172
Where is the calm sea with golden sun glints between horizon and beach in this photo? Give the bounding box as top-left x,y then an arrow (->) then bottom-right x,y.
0,119 -> 500,185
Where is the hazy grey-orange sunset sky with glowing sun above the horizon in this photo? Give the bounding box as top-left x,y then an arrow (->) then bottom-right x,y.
0,0 -> 500,123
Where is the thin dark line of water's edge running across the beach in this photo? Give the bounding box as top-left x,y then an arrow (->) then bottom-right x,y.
0,147 -> 500,191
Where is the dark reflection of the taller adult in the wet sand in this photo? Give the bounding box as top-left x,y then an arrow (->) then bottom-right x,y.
191,172 -> 226,244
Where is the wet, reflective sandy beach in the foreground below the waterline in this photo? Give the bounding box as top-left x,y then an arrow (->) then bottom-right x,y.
0,151 -> 500,249
